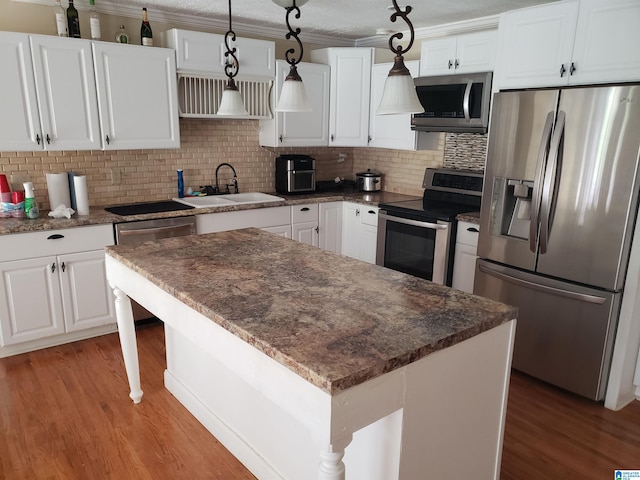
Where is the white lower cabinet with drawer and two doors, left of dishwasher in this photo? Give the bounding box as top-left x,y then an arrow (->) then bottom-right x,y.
0,224 -> 116,357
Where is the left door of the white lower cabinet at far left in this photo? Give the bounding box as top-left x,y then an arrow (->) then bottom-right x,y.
0,257 -> 64,346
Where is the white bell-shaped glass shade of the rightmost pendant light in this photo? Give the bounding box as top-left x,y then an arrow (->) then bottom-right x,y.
376,56 -> 424,115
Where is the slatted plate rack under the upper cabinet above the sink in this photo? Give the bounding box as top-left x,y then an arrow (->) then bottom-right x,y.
178,73 -> 273,120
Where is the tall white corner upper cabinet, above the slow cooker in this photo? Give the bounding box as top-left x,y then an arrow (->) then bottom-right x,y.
311,48 -> 373,147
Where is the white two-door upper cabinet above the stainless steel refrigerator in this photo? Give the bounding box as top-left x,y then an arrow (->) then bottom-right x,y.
494,0 -> 640,89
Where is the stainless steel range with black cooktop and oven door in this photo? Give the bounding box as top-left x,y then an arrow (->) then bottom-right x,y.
376,168 -> 483,286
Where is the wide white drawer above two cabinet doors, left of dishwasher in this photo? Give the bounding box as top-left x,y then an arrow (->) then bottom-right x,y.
0,223 -> 114,262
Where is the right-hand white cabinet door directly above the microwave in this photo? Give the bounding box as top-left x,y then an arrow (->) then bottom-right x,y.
456,30 -> 498,73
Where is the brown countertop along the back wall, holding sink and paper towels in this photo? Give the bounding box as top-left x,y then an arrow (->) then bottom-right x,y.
0,192 -> 420,235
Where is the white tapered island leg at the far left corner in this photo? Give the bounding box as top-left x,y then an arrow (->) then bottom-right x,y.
113,287 -> 142,403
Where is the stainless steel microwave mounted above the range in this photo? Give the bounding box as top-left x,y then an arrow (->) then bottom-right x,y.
411,72 -> 493,133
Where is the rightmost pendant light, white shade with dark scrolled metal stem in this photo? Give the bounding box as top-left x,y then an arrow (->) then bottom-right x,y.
376,0 -> 424,115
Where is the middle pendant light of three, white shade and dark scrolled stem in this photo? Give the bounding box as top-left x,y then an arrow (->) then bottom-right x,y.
273,0 -> 311,112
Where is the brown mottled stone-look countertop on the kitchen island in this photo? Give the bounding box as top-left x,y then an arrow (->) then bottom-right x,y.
106,228 -> 517,394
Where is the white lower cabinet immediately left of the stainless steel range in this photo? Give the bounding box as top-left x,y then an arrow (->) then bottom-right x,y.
342,202 -> 378,263
